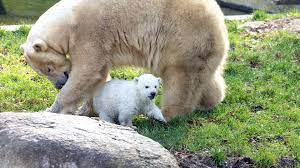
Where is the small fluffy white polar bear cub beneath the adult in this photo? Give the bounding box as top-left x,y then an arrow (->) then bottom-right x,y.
93,74 -> 166,127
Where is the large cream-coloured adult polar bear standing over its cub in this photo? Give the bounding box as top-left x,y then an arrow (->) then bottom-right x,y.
22,0 -> 228,120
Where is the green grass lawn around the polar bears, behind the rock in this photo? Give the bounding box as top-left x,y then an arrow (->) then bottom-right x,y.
0,14 -> 300,167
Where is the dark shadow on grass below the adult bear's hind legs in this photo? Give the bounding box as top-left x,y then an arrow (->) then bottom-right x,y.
134,110 -> 215,150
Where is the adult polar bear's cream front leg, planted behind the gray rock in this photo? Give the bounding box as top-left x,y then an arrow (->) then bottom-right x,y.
48,50 -> 109,114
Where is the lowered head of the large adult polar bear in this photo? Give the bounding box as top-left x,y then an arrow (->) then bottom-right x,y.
21,39 -> 71,89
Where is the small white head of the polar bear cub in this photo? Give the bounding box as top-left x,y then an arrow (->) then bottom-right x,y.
134,74 -> 161,100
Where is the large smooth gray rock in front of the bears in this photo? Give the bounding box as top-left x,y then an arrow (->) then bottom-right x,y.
0,113 -> 178,168
